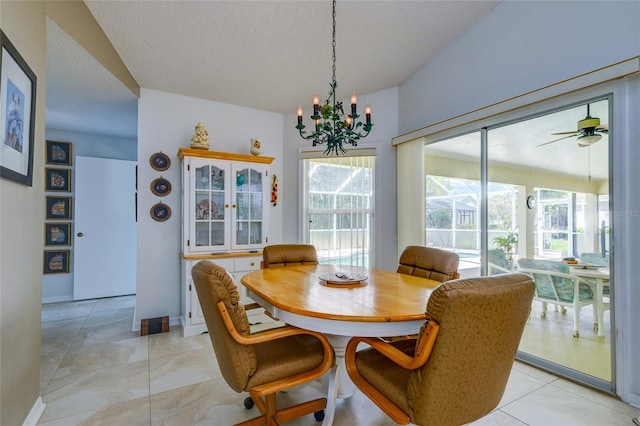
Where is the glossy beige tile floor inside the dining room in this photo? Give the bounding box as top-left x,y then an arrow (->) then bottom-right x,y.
39,296 -> 640,426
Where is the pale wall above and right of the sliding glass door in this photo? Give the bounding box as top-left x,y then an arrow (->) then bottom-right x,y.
399,1 -> 640,406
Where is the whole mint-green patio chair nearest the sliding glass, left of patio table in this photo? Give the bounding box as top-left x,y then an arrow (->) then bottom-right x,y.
518,258 -> 597,337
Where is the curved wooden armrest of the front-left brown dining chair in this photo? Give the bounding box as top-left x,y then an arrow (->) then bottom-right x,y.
217,301 -> 335,397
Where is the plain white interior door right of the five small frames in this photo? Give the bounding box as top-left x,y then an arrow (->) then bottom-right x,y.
73,157 -> 137,300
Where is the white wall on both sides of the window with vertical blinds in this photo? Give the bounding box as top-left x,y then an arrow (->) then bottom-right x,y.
278,86 -> 398,270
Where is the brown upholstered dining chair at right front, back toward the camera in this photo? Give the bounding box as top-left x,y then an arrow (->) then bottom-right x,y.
345,274 -> 535,426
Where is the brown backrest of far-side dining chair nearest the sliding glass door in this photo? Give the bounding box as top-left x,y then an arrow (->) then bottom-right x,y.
397,246 -> 460,282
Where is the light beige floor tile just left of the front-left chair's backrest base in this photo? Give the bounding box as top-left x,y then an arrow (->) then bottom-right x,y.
149,348 -> 222,395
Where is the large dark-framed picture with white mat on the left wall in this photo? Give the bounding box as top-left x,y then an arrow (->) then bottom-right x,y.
0,30 -> 36,186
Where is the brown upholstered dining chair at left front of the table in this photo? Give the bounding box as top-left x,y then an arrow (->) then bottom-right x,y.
191,260 -> 335,426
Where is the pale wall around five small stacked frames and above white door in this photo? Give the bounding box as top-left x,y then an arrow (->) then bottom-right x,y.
42,129 -> 138,303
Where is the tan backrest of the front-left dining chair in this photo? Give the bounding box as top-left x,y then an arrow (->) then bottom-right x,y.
191,260 -> 257,392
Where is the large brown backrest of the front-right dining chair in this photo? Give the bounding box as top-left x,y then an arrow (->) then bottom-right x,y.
407,274 -> 534,425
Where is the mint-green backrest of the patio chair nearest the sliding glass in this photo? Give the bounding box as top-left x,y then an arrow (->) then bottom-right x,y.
518,258 -> 593,303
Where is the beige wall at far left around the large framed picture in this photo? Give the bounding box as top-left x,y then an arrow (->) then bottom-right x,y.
0,1 -> 47,425
